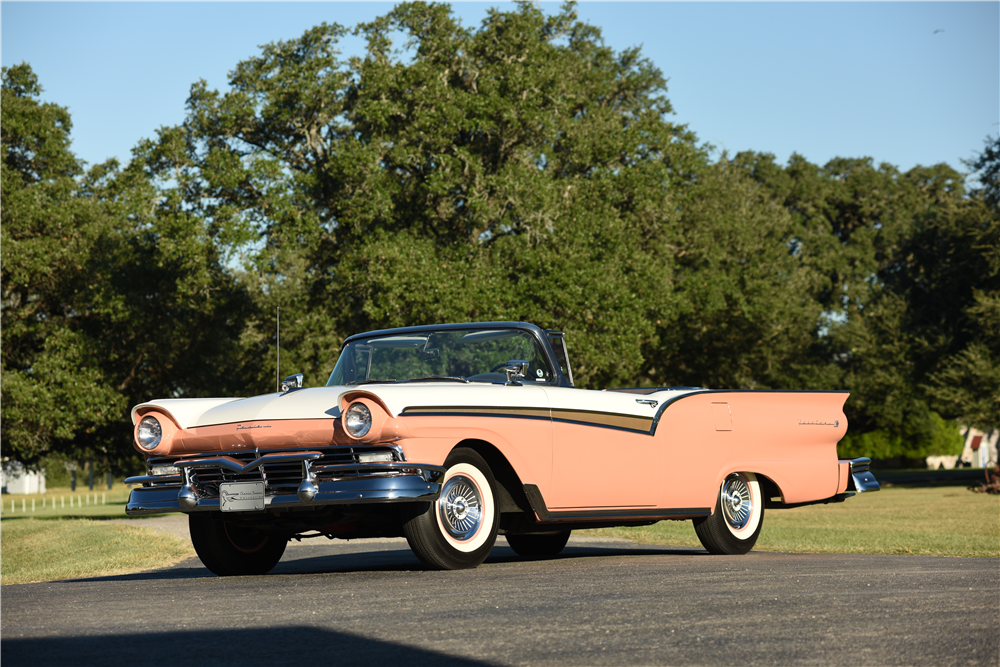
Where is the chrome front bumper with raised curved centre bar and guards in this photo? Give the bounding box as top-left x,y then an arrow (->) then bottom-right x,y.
125,460 -> 445,516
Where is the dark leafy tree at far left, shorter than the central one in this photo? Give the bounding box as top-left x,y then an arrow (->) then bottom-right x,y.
0,64 -> 248,469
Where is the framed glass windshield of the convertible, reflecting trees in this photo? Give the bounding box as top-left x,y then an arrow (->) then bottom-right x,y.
326,329 -> 553,387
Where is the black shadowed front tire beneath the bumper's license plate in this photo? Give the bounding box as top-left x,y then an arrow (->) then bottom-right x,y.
188,512 -> 288,577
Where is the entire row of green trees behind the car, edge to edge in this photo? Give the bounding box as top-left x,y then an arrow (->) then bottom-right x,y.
0,2 -> 1000,473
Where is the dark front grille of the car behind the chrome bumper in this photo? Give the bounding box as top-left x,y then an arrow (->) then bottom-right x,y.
147,446 -> 407,495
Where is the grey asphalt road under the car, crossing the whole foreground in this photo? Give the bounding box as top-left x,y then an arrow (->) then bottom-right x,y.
0,520 -> 1000,667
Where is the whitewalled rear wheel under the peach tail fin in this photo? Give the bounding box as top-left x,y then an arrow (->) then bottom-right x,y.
694,472 -> 764,554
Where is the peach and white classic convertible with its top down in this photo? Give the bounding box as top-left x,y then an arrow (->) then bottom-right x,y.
126,322 -> 879,575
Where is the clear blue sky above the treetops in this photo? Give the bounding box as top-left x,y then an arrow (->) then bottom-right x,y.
0,1 -> 1000,176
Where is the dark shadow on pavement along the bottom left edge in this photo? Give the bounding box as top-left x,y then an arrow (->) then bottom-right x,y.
0,626 -> 492,667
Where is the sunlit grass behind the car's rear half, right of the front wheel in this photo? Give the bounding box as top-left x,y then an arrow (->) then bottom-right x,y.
578,486 -> 1000,558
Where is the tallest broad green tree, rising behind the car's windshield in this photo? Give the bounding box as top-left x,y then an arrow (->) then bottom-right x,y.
145,3 -> 707,385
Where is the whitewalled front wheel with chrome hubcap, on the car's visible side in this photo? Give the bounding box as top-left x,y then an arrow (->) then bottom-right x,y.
403,448 -> 500,570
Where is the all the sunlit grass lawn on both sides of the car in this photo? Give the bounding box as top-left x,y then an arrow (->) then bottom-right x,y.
0,485 -> 1000,584
